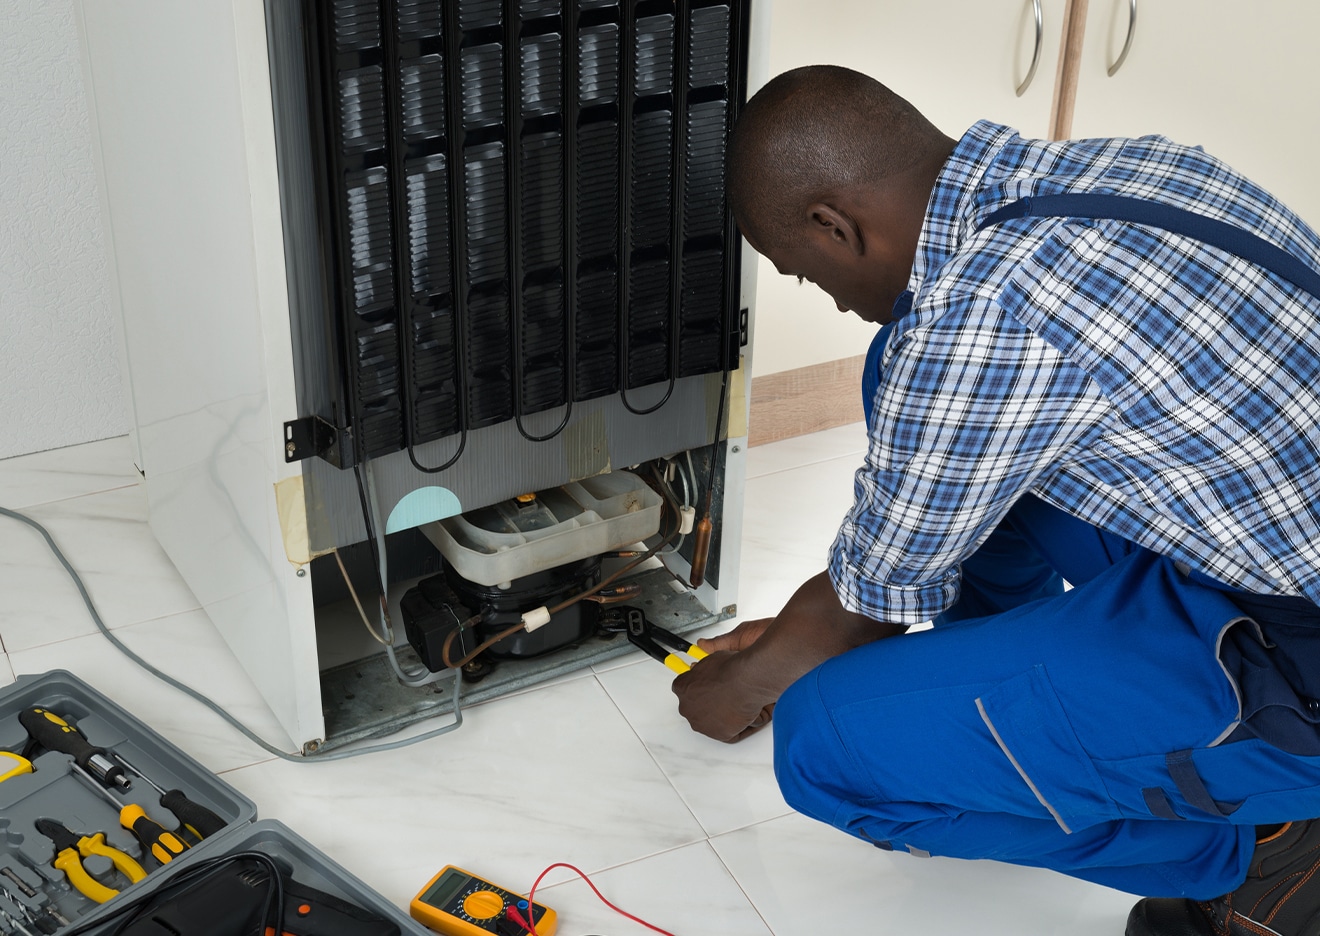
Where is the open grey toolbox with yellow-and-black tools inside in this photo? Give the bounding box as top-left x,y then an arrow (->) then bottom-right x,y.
0,671 -> 429,936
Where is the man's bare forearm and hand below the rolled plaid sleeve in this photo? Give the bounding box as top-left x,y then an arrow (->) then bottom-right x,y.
673,572 -> 907,742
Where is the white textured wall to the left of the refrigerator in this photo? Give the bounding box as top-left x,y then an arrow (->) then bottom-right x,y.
0,0 -> 128,458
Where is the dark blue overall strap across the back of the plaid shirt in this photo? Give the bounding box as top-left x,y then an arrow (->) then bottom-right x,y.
977,193 -> 1320,298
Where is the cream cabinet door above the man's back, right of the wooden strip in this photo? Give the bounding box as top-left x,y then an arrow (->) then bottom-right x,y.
1071,0 -> 1320,227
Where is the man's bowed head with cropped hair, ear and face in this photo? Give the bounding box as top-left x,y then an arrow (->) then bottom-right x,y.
729,65 -> 953,322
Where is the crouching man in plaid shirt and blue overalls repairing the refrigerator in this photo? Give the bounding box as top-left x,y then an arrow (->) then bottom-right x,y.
675,66 -> 1320,936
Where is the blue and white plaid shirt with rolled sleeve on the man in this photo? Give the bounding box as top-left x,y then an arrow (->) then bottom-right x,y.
829,121 -> 1320,624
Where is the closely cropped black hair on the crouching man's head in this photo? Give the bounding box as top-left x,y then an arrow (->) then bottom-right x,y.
726,65 -> 945,247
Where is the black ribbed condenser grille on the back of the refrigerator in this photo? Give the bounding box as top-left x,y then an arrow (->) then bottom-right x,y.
298,0 -> 746,467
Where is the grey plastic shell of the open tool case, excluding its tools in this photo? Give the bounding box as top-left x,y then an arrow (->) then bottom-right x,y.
0,671 -> 429,936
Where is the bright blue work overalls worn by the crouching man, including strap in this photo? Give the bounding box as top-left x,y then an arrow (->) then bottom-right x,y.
774,195 -> 1320,899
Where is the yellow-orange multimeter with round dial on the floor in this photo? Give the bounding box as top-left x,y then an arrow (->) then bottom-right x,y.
408,865 -> 558,936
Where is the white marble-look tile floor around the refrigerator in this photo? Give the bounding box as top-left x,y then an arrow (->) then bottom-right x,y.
0,425 -> 1134,936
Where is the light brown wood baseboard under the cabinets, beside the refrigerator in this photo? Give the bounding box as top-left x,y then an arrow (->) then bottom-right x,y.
747,354 -> 866,445
